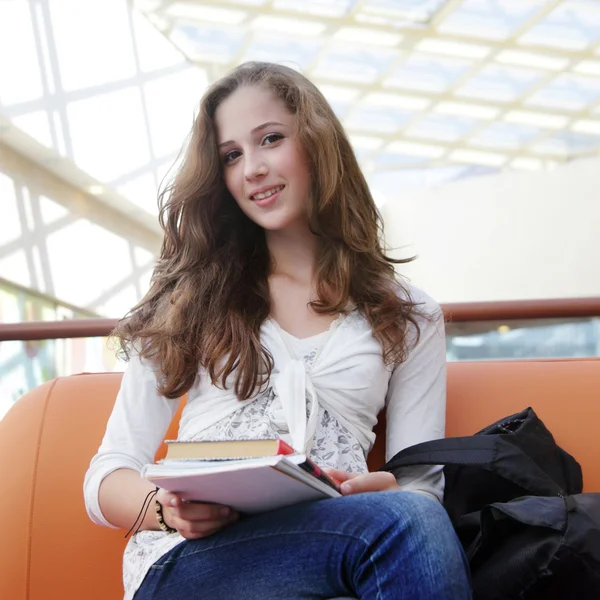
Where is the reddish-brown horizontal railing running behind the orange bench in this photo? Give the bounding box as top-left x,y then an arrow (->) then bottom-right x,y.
0,298 -> 600,342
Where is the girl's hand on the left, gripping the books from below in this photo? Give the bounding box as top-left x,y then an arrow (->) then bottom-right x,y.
156,488 -> 239,540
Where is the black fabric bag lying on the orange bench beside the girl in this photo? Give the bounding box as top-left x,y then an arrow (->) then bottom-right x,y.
381,408 -> 600,600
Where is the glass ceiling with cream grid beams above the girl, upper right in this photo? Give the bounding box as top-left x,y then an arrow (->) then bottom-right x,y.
134,0 -> 600,174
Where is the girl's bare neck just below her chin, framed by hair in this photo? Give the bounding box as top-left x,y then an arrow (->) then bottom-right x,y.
266,227 -> 318,283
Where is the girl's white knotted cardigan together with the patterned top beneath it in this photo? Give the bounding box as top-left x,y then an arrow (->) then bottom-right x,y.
84,286 -> 446,600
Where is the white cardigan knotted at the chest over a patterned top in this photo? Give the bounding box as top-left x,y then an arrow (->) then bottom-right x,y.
84,286 -> 446,526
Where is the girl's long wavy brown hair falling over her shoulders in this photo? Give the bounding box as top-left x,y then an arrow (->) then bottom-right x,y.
114,62 -> 419,400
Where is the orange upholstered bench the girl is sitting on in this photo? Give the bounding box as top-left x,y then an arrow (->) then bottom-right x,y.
0,359 -> 600,600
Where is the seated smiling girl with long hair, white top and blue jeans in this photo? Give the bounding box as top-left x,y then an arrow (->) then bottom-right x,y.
85,63 -> 470,600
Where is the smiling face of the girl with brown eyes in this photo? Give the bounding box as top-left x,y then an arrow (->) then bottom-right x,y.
215,86 -> 310,231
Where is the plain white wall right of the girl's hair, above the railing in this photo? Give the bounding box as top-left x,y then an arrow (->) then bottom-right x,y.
383,158 -> 600,302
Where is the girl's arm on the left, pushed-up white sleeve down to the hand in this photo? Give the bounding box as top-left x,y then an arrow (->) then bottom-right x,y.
84,356 -> 238,539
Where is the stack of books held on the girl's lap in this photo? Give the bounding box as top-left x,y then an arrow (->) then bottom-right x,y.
142,439 -> 341,514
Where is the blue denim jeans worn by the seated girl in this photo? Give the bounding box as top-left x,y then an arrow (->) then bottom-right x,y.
135,491 -> 471,600
